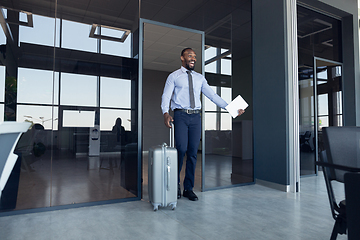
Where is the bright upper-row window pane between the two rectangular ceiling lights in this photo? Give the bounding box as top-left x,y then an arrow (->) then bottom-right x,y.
61,20 -> 97,52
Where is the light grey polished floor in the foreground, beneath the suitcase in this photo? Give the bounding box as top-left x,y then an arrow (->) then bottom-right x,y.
0,172 -> 346,240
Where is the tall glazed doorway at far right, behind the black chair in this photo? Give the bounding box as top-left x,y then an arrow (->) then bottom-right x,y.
297,4 -> 343,176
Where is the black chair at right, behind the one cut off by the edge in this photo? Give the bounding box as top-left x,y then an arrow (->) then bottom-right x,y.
316,127 -> 360,240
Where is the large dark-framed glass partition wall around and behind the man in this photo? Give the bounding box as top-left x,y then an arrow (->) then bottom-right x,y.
0,0 -> 254,212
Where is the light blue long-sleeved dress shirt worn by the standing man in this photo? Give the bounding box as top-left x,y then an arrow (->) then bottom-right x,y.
161,66 -> 228,114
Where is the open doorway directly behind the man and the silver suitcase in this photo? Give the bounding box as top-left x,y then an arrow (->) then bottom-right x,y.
139,19 -> 204,195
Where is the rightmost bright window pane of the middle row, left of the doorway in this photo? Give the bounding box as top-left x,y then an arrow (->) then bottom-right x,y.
100,77 -> 131,109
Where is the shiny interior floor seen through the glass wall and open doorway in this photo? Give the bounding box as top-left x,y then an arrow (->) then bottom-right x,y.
15,151 -> 253,210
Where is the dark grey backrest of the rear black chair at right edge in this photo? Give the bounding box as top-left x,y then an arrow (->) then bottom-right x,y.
323,127 -> 360,182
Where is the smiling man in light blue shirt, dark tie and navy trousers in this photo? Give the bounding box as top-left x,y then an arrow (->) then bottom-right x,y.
161,48 -> 245,201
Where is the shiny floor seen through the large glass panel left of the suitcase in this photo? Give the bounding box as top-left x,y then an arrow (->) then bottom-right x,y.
15,152 -> 136,210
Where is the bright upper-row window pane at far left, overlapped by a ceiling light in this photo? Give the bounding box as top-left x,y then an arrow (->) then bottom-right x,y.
19,14 -> 60,47
